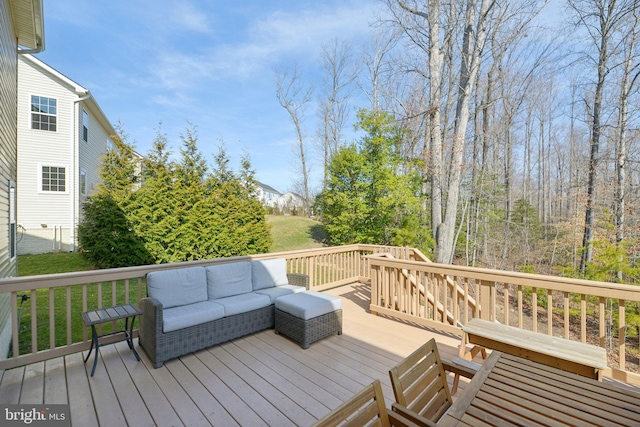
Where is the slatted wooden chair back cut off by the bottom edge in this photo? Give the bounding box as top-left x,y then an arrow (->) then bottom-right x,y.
314,380 -> 390,427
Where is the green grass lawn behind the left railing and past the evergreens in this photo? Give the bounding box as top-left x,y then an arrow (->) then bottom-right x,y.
12,215 -> 324,354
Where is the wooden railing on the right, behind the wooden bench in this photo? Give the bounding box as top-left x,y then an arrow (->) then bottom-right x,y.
368,256 -> 640,384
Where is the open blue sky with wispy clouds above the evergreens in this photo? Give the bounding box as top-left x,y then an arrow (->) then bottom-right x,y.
38,0 -> 381,192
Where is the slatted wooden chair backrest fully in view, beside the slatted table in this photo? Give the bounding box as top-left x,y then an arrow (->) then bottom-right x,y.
389,338 -> 453,423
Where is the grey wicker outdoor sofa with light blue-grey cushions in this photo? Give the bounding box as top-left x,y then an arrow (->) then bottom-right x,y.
139,258 -> 309,368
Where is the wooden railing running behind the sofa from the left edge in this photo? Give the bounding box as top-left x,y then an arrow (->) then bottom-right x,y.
0,245 -> 421,370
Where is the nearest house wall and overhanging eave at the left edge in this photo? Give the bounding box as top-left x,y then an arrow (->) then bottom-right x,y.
0,0 -> 44,358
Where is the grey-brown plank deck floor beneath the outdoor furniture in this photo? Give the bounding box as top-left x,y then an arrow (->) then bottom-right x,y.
0,284 -> 466,427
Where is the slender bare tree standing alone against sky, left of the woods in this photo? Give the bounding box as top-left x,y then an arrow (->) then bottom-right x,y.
276,66 -> 313,213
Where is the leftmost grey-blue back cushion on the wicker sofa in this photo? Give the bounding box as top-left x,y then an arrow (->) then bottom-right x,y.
147,267 -> 207,308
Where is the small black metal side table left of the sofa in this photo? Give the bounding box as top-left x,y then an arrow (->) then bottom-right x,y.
82,304 -> 142,376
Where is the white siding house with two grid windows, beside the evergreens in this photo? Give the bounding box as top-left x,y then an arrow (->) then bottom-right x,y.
17,55 -> 115,254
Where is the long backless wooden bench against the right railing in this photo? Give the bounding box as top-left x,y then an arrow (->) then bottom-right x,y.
460,319 -> 607,380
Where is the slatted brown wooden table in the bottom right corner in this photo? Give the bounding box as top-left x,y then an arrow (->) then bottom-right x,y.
438,351 -> 640,427
